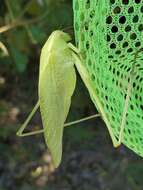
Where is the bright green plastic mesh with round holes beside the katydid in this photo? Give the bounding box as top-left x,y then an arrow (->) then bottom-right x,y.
73,0 -> 143,156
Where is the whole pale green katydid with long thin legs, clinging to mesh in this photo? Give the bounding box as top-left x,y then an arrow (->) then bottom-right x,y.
17,31 -> 134,167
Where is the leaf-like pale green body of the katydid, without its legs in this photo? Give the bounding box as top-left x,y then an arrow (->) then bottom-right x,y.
39,31 -> 76,167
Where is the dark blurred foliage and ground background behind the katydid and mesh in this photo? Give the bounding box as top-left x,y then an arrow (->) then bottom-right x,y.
0,0 -> 143,190
